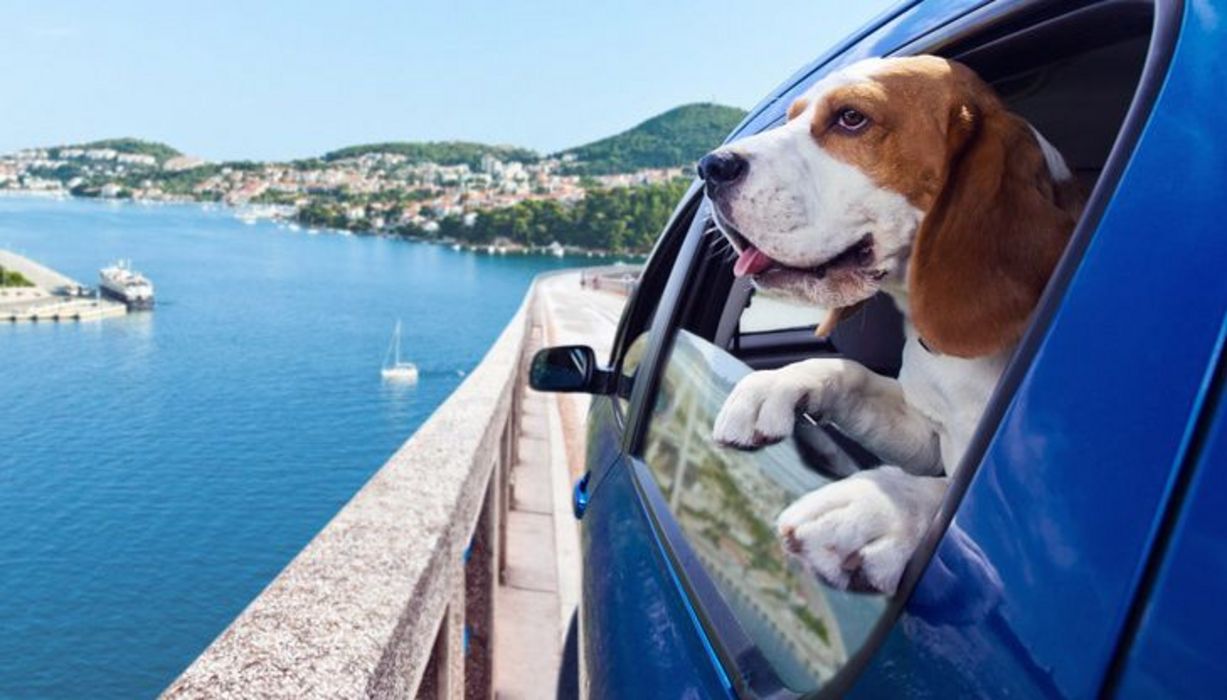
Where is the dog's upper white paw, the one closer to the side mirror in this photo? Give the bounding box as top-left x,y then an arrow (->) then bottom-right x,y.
712,360 -> 843,448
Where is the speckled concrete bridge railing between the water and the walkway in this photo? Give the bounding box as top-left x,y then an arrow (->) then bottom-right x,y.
163,286 -> 536,699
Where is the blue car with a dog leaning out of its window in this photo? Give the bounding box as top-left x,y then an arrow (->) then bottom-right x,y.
534,0 -> 1227,699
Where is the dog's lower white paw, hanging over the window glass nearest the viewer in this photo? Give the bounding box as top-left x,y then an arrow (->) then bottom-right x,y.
775,467 -> 946,594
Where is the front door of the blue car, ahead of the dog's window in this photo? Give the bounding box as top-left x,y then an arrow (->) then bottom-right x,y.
577,189 -> 728,698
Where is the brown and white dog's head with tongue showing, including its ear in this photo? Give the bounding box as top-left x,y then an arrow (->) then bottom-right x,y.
699,56 -> 1080,356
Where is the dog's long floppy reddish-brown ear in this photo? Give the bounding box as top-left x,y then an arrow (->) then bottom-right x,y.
908,85 -> 1077,357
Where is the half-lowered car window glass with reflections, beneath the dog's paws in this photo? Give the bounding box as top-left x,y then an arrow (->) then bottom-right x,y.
643,330 -> 885,690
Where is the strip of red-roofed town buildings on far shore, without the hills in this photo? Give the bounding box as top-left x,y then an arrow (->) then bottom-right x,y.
0,140 -> 683,244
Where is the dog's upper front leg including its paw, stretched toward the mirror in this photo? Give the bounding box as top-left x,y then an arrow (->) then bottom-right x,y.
712,357 -> 942,474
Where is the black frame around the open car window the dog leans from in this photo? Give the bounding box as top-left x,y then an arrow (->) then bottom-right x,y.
623,0 -> 1184,699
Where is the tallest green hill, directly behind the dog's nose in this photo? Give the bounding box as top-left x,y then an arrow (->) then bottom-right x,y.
558,103 -> 746,176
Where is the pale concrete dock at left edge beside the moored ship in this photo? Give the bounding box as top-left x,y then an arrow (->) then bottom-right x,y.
0,249 -> 128,323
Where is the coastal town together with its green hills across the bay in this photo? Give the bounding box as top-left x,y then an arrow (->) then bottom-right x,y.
0,103 -> 745,254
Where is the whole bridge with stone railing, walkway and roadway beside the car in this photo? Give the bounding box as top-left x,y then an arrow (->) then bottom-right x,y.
163,268 -> 627,699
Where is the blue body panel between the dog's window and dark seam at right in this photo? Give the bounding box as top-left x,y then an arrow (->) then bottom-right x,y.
855,2 -> 1227,698
